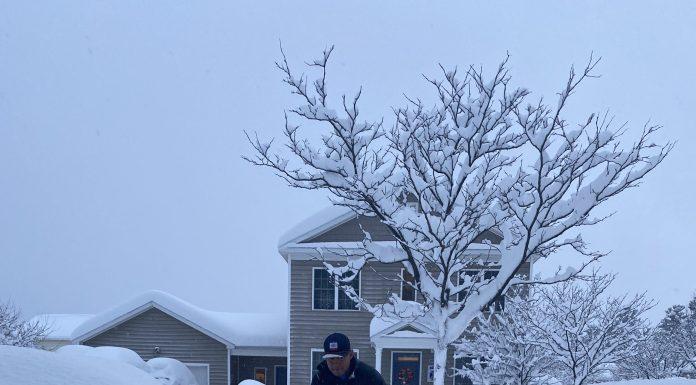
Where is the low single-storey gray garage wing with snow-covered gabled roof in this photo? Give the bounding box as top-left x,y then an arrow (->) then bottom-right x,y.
34,290 -> 288,385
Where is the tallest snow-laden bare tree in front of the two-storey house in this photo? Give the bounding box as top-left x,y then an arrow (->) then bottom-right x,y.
245,47 -> 672,385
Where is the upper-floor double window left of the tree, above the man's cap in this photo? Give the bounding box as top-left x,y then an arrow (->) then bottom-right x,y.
312,268 -> 360,310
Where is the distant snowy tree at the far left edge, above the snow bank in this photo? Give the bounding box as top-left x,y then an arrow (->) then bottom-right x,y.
0,301 -> 49,347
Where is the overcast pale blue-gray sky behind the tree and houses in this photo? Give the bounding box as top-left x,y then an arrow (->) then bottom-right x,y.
0,0 -> 696,319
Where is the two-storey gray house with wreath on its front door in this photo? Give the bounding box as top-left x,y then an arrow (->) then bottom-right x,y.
278,206 -> 531,385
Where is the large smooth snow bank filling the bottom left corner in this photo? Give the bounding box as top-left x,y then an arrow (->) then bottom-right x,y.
0,346 -> 162,385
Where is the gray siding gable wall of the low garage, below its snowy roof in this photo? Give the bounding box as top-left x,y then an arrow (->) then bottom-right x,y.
82,308 -> 228,385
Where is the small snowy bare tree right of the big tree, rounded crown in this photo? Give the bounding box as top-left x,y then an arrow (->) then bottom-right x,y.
526,272 -> 653,385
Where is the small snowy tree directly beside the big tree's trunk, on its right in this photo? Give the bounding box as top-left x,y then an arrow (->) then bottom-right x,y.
455,295 -> 557,385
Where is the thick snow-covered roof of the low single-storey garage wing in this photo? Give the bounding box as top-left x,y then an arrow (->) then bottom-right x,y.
72,290 -> 288,347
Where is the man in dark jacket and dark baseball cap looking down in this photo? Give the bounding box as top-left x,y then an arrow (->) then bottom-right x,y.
312,333 -> 385,385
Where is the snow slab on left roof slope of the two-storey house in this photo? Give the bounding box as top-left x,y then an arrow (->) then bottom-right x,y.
278,205 -> 355,249
